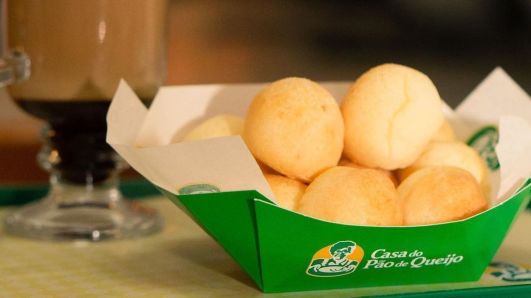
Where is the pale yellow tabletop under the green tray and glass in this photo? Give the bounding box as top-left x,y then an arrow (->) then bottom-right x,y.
0,197 -> 531,297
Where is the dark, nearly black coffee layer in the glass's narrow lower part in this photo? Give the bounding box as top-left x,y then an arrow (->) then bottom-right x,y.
16,99 -> 148,184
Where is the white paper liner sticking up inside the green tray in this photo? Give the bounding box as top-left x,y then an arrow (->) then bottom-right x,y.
107,68 -> 531,205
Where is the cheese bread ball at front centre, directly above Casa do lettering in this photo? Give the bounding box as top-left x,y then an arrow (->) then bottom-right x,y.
296,166 -> 402,226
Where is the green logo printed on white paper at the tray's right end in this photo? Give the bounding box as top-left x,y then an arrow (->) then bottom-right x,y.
467,126 -> 500,171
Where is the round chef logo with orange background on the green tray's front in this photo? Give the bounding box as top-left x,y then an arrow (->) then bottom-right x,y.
306,241 -> 363,277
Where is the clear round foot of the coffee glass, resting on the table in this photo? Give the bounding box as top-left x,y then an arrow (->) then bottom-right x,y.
5,178 -> 162,241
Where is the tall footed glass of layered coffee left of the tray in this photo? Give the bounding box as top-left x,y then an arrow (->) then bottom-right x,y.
5,0 -> 167,240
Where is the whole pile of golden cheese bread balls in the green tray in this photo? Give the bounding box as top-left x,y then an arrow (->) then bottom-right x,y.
184,64 -> 490,226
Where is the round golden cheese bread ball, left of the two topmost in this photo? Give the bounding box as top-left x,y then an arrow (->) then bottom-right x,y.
243,78 -> 343,182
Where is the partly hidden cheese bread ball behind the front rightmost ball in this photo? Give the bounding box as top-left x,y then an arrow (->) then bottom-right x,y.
398,141 -> 490,197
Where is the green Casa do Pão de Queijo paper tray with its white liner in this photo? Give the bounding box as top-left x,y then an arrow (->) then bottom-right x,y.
107,68 -> 531,292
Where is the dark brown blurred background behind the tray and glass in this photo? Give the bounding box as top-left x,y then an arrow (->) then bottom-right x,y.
0,0 -> 531,184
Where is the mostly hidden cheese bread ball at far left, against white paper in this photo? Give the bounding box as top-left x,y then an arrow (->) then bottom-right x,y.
183,115 -> 244,141
